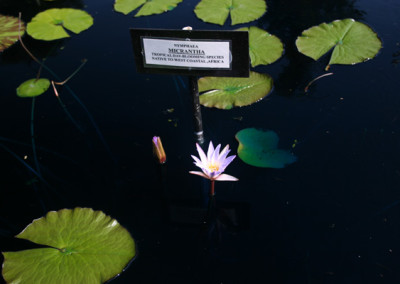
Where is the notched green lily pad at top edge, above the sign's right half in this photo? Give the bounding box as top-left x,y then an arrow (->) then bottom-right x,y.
194,0 -> 267,26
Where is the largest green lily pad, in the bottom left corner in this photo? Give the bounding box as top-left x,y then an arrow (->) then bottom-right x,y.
2,208 -> 135,284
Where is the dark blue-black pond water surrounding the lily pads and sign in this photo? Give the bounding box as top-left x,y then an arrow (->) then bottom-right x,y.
0,0 -> 400,284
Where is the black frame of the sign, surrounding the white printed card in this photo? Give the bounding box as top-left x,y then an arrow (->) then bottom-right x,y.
130,28 -> 250,77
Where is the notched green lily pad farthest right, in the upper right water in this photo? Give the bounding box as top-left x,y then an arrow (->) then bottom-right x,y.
296,19 -> 382,65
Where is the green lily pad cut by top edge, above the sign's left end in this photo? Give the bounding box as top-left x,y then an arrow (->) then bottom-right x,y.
114,0 -> 183,17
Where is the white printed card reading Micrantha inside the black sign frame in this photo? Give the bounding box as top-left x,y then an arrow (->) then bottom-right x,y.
142,38 -> 231,69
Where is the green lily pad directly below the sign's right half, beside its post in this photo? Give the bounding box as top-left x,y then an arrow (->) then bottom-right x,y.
199,72 -> 273,109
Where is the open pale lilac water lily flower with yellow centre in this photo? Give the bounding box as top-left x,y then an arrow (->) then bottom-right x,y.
189,142 -> 238,181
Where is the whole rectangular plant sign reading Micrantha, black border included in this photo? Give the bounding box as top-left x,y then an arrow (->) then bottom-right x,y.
130,29 -> 250,77
